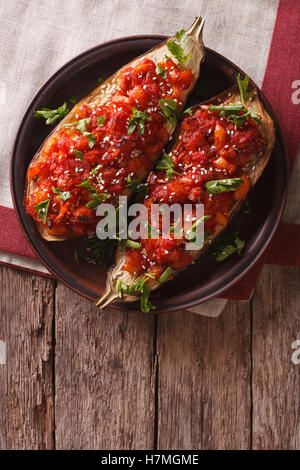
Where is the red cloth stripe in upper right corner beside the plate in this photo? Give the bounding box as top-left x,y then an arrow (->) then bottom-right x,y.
262,0 -> 300,169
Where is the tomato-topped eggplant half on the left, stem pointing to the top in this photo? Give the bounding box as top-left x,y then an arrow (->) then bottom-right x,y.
24,18 -> 204,241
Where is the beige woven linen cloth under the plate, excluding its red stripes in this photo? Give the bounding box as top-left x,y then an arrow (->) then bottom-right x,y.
0,0 -> 278,316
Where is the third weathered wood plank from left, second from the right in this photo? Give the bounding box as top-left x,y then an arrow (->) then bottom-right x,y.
157,302 -> 251,449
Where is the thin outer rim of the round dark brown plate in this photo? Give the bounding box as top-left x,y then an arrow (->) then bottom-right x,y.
10,34 -> 290,314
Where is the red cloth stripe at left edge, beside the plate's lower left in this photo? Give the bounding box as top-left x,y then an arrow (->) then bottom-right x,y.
0,206 -> 36,258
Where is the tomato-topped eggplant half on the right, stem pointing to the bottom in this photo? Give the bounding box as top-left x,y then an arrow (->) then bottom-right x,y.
97,77 -> 274,311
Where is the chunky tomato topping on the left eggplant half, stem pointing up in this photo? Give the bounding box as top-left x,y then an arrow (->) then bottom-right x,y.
25,59 -> 193,237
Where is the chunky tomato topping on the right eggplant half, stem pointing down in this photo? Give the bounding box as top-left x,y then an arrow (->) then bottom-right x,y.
123,106 -> 264,279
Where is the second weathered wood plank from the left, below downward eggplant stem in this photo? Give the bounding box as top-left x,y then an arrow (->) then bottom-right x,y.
55,285 -> 155,449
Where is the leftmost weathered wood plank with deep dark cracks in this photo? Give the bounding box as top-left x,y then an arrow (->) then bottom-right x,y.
0,266 -> 54,449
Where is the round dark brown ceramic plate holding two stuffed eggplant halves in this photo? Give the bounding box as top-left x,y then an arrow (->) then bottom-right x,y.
11,36 -> 288,312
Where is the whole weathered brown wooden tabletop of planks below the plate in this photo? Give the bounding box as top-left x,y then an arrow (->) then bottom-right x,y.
0,266 -> 300,449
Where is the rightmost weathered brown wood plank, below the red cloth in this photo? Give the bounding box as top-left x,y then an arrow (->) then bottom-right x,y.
252,266 -> 300,449
